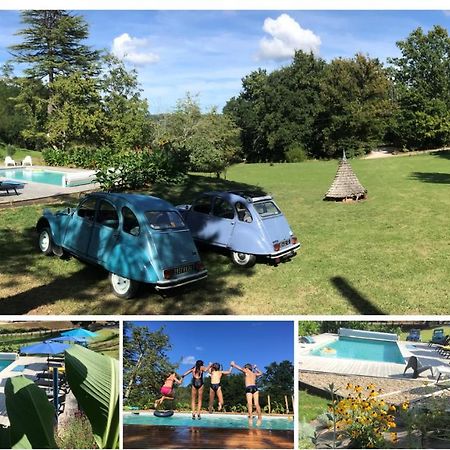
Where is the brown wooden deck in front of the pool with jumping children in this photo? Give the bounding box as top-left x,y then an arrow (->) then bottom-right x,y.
123,425 -> 294,449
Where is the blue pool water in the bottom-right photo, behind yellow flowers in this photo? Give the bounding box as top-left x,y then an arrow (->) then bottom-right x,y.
311,336 -> 405,364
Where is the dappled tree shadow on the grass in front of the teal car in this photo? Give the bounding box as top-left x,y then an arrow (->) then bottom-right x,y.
0,221 -> 244,314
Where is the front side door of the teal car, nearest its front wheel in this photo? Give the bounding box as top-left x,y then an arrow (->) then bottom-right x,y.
63,197 -> 97,257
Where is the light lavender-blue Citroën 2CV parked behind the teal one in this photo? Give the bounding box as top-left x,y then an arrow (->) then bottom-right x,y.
177,191 -> 300,267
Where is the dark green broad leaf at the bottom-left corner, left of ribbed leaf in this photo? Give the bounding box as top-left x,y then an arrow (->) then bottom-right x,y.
5,376 -> 58,448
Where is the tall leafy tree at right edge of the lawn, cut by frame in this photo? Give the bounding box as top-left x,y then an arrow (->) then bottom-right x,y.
389,25 -> 450,148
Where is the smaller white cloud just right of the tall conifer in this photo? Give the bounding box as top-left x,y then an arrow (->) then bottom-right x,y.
111,33 -> 159,66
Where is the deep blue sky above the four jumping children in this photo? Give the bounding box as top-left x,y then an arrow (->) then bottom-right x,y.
128,321 -> 294,385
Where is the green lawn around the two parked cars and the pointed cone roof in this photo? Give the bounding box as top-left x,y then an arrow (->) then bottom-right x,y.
0,152 -> 450,315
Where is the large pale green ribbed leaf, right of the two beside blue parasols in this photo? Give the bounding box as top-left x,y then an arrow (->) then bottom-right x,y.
65,345 -> 119,448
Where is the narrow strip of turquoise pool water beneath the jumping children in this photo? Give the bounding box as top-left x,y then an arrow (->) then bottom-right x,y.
123,413 -> 294,430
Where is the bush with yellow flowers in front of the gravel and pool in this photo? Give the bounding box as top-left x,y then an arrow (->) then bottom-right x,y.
329,383 -> 409,448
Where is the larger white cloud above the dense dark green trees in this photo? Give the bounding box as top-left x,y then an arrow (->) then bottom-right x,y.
258,14 -> 322,61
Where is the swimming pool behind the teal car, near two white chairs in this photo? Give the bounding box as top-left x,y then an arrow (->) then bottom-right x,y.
0,167 -> 94,187
